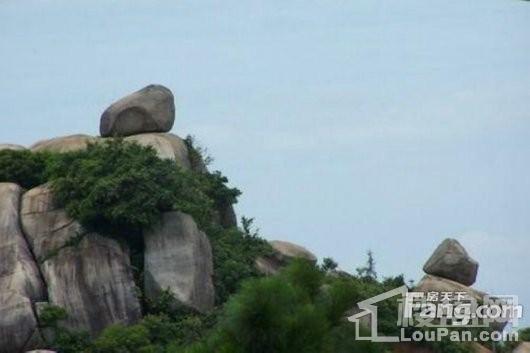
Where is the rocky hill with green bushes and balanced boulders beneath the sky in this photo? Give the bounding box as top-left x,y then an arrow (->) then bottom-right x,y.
0,85 -> 520,353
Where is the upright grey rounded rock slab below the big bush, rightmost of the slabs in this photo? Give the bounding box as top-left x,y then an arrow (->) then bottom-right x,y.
144,212 -> 215,312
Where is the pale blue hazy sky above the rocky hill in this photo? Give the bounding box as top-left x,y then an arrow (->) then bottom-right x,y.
0,0 -> 530,325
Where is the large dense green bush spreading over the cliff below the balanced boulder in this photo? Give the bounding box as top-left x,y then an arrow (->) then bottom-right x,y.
49,140 -> 239,236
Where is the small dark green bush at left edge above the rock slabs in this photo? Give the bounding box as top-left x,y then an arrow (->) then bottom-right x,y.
0,150 -> 50,189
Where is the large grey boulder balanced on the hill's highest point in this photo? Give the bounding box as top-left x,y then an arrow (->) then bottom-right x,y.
99,85 -> 175,137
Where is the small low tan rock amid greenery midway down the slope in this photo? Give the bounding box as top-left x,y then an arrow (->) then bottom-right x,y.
255,240 -> 317,276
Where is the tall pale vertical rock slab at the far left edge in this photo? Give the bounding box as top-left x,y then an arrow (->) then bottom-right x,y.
0,183 -> 46,353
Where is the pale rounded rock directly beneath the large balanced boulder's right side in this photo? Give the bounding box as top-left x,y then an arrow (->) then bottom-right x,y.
124,133 -> 191,169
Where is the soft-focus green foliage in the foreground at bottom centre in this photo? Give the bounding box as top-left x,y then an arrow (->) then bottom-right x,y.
175,261 -> 397,353
